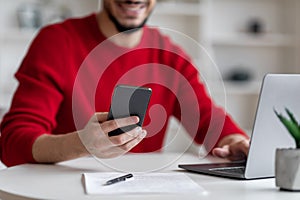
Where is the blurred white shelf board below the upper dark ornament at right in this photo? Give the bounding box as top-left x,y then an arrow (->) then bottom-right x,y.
211,33 -> 294,47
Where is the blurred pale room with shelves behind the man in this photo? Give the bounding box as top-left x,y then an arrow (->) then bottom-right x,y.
0,0 -> 300,153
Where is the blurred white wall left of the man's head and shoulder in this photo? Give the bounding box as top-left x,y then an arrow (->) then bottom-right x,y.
0,0 -> 99,119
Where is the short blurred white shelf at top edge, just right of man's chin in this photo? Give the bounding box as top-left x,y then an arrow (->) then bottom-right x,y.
153,1 -> 204,16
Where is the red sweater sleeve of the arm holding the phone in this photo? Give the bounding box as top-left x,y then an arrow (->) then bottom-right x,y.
1,27 -> 66,166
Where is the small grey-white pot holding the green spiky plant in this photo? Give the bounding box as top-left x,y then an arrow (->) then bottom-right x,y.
275,149 -> 300,191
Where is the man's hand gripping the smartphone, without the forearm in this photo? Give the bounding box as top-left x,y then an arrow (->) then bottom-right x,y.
78,113 -> 147,158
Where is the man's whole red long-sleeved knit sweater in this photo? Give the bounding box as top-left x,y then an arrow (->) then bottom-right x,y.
0,15 -> 244,166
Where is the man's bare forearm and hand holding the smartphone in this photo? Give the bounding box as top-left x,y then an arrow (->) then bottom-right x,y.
32,113 -> 146,163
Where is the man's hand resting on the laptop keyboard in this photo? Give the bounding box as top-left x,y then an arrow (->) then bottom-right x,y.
212,134 -> 249,160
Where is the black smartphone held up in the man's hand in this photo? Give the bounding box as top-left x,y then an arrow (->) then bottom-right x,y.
108,85 -> 152,136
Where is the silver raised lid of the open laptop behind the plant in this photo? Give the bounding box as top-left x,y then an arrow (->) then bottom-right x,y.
245,74 -> 300,178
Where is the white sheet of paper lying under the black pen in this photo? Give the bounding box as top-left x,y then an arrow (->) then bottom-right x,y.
83,172 -> 204,195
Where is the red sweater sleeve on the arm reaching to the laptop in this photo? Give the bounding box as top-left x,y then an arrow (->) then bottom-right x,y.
175,52 -> 248,152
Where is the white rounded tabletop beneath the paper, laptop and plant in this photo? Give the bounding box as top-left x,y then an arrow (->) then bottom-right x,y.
0,153 -> 300,200
